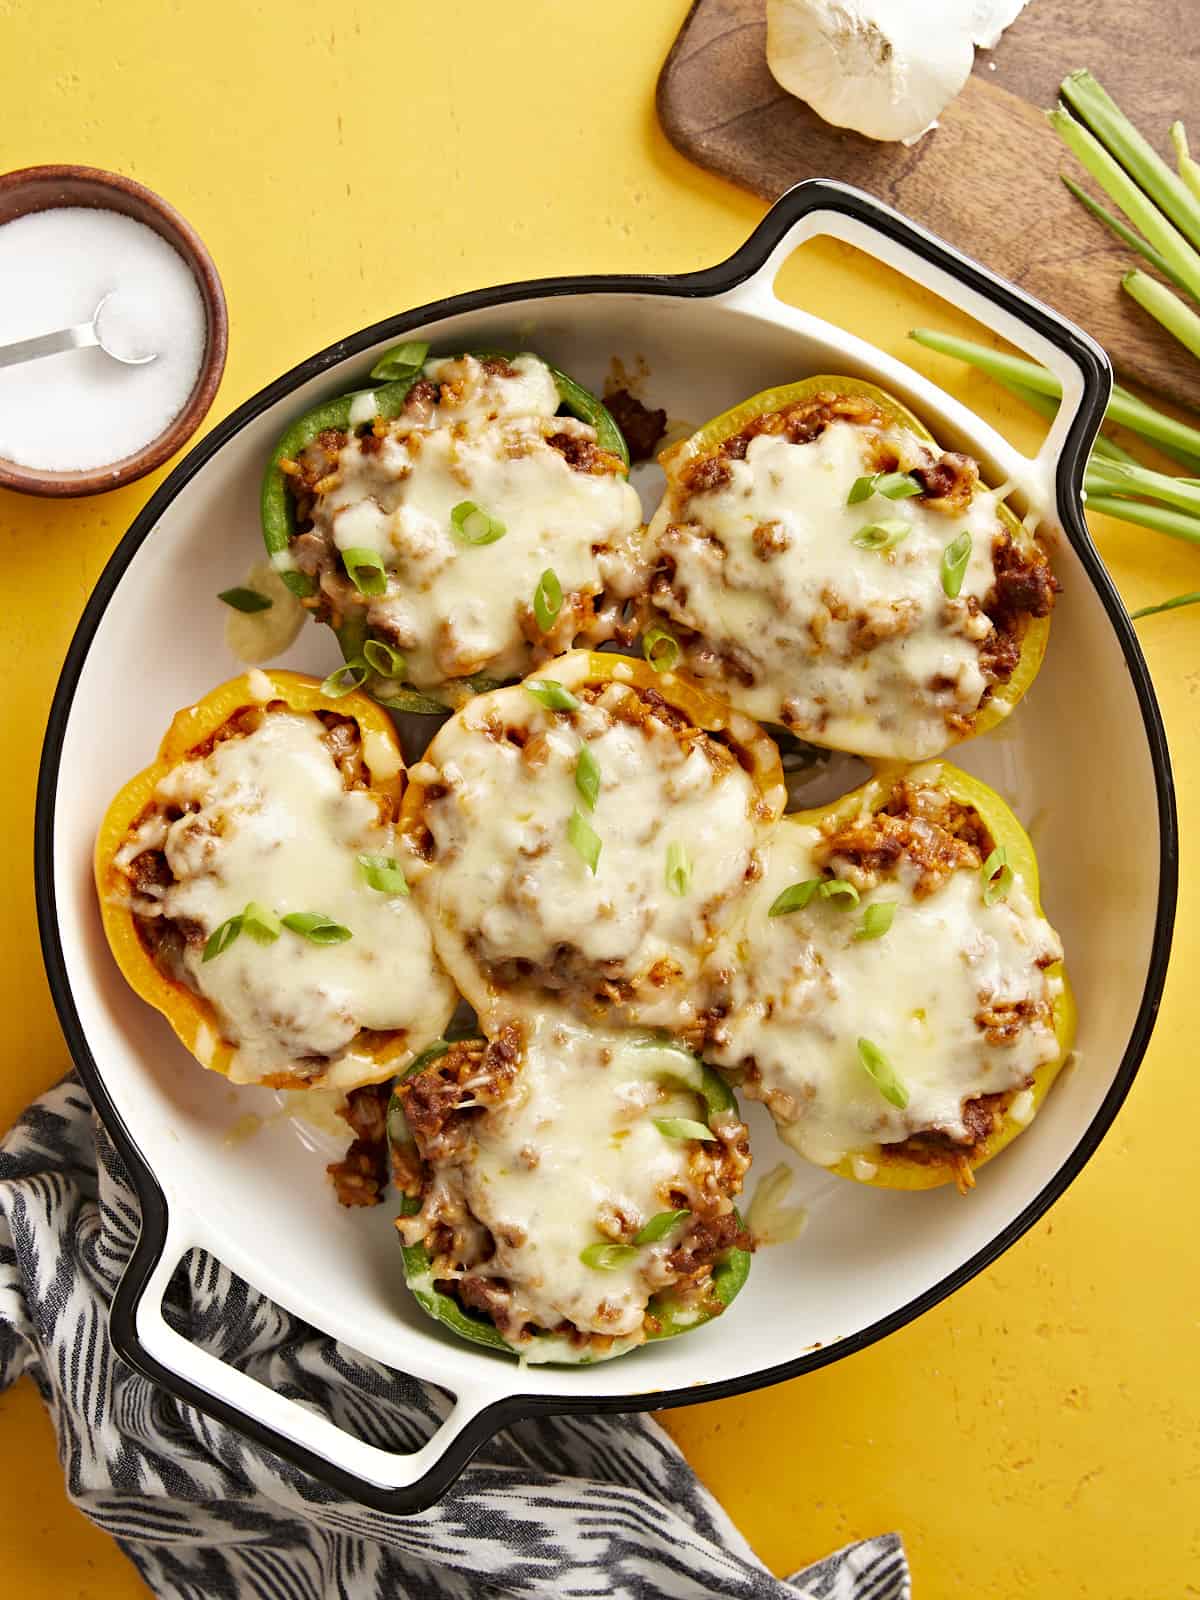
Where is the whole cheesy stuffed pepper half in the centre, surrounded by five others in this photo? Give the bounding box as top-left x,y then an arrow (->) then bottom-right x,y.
402,651 -> 786,1037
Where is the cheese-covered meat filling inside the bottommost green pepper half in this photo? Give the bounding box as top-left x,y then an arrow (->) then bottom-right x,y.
392,1014 -> 750,1360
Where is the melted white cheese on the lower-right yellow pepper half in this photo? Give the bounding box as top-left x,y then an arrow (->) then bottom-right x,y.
707,822 -> 1062,1166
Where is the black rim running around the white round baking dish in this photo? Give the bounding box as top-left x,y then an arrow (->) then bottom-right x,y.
34,179 -> 1178,1512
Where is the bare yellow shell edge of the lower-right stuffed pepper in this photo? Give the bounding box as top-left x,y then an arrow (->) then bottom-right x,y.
782,762 -> 1075,1189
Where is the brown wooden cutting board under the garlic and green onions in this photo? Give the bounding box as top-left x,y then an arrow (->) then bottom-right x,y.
658,0 -> 1200,406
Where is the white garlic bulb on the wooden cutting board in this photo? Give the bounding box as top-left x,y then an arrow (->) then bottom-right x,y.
766,0 -> 1024,144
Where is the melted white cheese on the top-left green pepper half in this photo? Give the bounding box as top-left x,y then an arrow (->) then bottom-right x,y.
314,355 -> 642,688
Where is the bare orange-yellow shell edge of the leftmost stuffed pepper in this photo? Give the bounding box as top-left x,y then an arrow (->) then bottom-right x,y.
94,670 -> 411,1088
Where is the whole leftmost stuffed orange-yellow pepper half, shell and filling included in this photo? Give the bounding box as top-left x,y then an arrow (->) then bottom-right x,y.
94,670 -> 458,1091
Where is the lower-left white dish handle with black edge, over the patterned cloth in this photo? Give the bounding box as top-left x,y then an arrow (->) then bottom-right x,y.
110,1218 -> 496,1514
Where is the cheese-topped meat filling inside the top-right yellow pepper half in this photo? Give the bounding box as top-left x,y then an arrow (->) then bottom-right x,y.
650,394 -> 1058,760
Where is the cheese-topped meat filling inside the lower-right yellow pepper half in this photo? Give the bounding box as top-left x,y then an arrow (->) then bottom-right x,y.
706,776 -> 1062,1176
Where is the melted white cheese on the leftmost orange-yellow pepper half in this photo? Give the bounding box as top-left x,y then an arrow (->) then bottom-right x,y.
125,712 -> 454,1086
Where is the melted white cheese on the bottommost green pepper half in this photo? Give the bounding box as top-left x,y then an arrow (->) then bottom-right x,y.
422,1014 -> 723,1360
